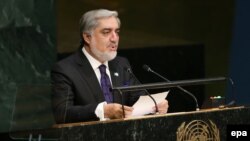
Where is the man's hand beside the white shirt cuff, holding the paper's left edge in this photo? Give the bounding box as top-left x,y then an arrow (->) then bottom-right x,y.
104,103 -> 133,119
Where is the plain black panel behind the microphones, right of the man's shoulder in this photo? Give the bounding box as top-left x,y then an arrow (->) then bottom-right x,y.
118,44 -> 205,112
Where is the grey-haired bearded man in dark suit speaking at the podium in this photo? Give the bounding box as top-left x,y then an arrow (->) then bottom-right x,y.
51,9 -> 168,123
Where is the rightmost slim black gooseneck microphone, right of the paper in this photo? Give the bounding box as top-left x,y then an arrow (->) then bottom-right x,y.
143,65 -> 200,111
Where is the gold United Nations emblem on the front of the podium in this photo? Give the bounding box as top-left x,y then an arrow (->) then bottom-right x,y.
176,120 -> 220,141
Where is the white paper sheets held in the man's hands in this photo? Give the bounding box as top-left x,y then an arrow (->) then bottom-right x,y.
131,91 -> 169,116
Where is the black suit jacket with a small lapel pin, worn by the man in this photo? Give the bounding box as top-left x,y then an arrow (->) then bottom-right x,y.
51,49 -> 140,123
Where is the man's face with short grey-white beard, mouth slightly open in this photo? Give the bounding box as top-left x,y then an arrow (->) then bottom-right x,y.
87,17 -> 119,62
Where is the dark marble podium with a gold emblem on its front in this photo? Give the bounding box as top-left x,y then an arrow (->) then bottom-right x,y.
10,107 -> 250,141
